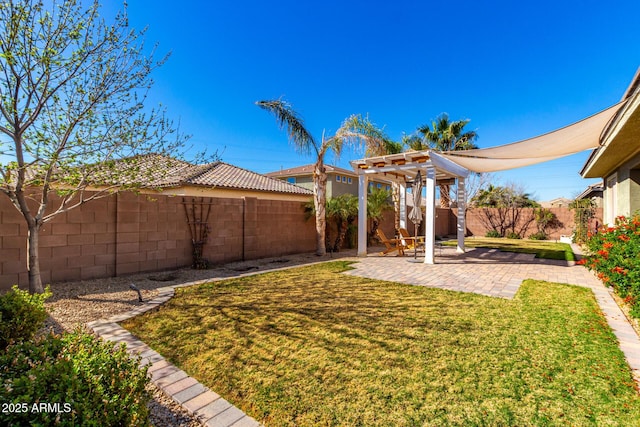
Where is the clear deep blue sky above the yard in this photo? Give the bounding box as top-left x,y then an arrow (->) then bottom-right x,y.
105,0 -> 640,200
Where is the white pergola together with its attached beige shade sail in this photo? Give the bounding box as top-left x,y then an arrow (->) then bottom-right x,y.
351,101 -> 636,264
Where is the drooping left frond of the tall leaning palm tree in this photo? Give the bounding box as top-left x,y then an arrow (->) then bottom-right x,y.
256,99 -> 318,154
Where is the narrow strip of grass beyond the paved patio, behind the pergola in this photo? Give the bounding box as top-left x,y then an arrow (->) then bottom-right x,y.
442,237 -> 575,261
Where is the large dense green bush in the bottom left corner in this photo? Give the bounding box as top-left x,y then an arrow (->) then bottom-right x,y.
0,330 -> 149,426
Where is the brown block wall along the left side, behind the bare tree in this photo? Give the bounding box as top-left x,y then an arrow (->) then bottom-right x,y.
0,193 -> 315,291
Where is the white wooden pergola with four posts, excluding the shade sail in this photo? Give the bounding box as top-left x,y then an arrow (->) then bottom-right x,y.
351,150 -> 470,264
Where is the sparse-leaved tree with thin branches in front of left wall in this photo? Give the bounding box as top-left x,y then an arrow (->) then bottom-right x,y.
0,0 -> 192,292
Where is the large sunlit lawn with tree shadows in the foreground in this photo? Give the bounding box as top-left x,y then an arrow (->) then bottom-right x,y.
124,262 -> 640,426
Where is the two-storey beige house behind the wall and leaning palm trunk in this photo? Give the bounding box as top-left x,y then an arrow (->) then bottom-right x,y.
265,165 -> 391,198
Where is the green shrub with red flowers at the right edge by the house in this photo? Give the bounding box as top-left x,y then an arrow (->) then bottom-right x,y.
580,213 -> 640,317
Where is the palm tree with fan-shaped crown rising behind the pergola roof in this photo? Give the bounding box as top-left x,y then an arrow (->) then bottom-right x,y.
418,113 -> 478,208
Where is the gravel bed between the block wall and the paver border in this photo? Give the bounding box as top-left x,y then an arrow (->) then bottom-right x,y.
45,251 -> 355,427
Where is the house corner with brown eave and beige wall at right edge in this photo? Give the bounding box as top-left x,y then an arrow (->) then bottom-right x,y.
580,68 -> 640,224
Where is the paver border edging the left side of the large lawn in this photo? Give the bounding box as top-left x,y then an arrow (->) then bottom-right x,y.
87,282 -> 263,427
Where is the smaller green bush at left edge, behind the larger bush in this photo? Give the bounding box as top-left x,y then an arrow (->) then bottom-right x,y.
0,286 -> 51,349
